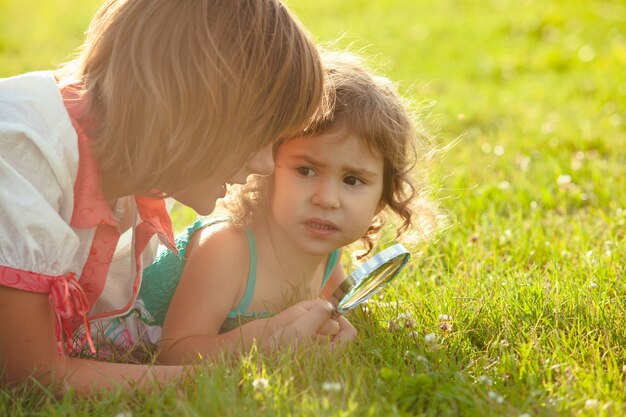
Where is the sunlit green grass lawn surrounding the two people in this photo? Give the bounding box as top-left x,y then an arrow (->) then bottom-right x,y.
0,0 -> 626,416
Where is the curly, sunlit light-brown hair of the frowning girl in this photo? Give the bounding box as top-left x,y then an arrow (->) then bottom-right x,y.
224,52 -> 437,257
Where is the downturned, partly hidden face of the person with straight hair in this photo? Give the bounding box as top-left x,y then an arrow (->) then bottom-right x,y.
170,145 -> 274,215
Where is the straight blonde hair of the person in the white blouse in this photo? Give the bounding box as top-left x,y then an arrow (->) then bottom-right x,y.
57,0 -> 323,193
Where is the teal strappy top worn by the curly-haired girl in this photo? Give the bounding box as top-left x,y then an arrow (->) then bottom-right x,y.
137,217 -> 339,332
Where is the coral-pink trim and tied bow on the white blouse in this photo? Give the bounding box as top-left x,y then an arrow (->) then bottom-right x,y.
0,86 -> 177,354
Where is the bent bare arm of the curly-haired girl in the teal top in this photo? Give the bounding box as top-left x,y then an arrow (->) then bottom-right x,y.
159,225 -> 340,363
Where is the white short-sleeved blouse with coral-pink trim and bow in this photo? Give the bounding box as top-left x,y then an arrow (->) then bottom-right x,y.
0,72 -> 175,352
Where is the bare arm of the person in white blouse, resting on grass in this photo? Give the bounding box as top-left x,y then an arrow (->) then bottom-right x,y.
0,286 -> 184,394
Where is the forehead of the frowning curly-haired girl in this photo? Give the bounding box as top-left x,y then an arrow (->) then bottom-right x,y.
277,129 -> 383,170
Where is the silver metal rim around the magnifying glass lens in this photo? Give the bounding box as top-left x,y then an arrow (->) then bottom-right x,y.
330,243 -> 411,314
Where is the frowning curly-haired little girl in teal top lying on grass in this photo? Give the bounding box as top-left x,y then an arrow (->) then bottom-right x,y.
109,54 -> 434,363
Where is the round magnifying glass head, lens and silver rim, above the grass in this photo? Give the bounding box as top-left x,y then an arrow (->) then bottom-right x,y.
328,243 -> 411,314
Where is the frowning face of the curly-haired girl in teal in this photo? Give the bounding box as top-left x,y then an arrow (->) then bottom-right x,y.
271,130 -> 383,255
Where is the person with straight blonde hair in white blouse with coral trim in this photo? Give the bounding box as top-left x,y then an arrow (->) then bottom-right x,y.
0,0 -> 344,391
